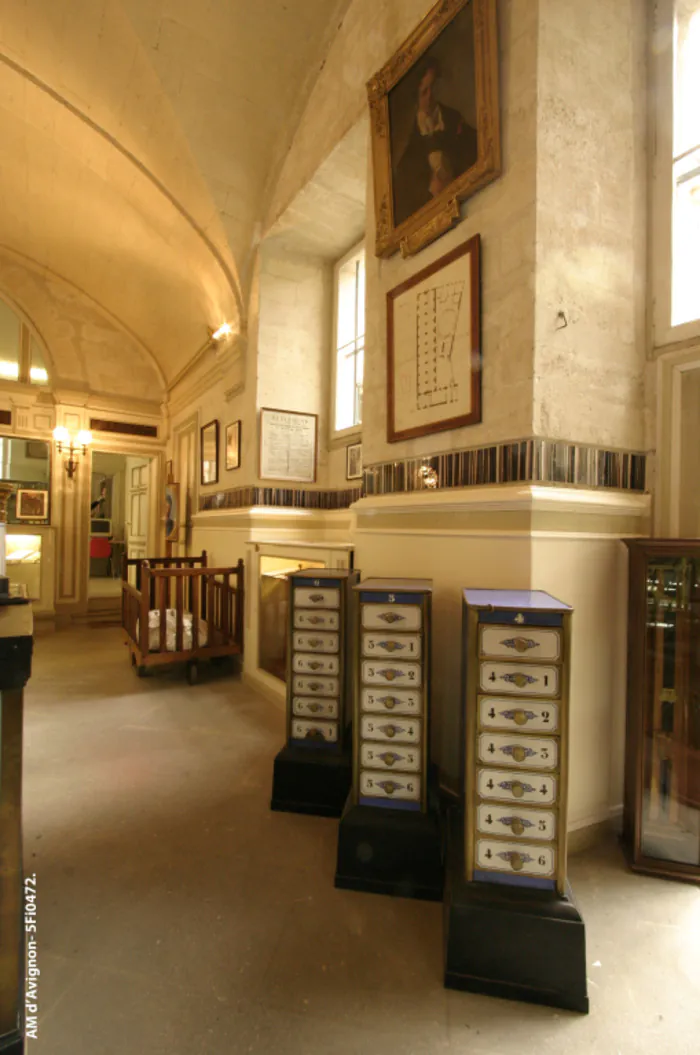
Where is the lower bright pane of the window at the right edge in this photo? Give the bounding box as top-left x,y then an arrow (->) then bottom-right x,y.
672,148 -> 700,326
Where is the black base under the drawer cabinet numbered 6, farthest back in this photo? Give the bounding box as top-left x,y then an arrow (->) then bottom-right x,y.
270,745 -> 352,817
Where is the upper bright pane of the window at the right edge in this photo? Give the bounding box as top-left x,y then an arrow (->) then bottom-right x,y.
674,6 -> 700,157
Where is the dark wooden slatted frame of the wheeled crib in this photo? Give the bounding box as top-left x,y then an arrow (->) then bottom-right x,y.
121,550 -> 245,674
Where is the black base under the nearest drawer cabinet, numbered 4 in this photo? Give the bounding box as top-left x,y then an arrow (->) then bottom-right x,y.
445,843 -> 588,1014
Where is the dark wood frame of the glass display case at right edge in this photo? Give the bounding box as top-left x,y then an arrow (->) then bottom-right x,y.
622,538 -> 700,883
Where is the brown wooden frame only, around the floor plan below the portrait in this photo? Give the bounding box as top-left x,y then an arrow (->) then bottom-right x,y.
387,234 -> 482,443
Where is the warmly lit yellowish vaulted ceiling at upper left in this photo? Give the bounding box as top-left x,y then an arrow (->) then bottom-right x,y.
0,0 -> 349,394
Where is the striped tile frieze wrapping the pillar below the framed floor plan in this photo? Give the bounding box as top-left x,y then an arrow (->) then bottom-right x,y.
363,439 -> 646,496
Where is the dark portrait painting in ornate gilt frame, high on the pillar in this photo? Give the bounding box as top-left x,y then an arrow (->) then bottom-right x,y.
367,0 -> 501,256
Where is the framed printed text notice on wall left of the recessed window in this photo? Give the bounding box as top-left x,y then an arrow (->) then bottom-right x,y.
260,407 -> 318,483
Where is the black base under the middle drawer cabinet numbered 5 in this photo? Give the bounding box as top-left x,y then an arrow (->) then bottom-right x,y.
335,801 -> 444,901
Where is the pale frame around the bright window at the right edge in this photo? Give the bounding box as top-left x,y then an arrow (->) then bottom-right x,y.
649,0 -> 700,349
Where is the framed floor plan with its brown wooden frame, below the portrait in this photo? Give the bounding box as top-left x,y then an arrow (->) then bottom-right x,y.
387,235 -> 482,443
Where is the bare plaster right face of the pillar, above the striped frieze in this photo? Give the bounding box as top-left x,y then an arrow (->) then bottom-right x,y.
533,0 -> 647,449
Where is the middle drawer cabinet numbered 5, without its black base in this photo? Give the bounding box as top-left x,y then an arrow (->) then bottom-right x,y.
353,579 -> 432,812
